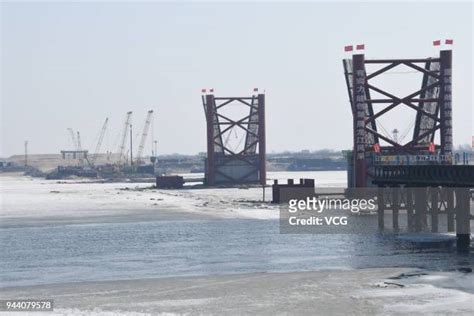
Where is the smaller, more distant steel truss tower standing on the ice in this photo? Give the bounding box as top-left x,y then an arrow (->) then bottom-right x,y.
202,90 -> 266,186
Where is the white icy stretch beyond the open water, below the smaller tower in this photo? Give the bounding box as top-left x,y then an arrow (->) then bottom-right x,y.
0,176 -> 279,227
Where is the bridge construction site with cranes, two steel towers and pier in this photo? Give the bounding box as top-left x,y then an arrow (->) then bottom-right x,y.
0,39 -> 474,248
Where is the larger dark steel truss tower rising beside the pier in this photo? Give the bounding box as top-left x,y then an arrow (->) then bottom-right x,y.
343,44 -> 453,187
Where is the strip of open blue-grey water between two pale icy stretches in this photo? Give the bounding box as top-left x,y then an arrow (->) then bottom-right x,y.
0,218 -> 474,287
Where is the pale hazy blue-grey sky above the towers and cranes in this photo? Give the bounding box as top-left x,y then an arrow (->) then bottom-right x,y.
0,1 -> 474,156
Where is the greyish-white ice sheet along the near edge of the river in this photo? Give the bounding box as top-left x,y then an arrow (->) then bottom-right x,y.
0,268 -> 474,315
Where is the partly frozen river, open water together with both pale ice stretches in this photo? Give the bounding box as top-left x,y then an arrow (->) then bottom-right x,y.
0,174 -> 474,315
